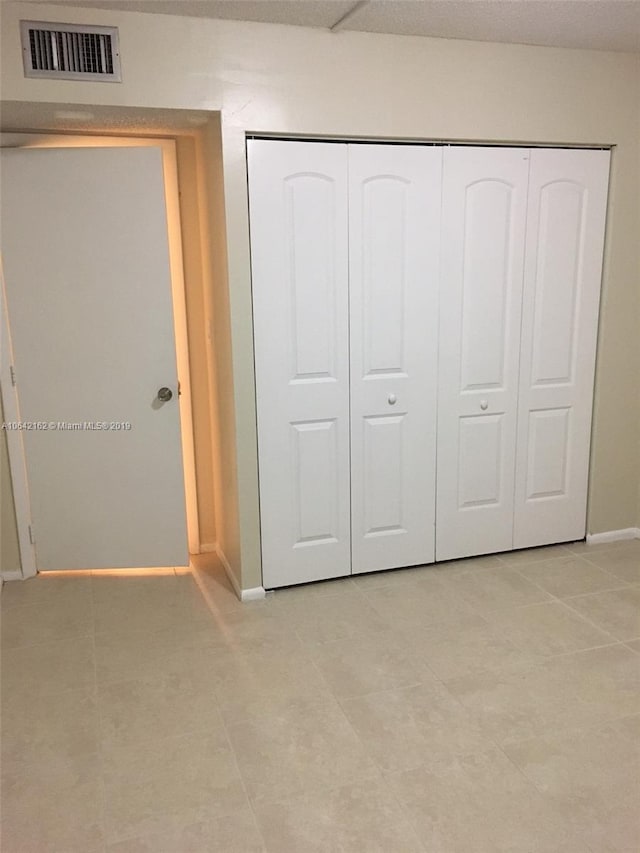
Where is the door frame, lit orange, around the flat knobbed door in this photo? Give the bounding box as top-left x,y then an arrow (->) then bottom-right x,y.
0,132 -> 200,580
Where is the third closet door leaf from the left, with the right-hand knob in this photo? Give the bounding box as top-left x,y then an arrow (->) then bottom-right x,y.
436,148 -> 529,560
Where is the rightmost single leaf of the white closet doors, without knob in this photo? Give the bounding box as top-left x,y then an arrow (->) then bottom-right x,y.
514,149 -> 609,548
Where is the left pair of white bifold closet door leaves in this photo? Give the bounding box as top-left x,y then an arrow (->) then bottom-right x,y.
248,140 -> 442,588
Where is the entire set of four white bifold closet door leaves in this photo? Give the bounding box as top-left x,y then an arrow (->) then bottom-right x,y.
248,140 -> 609,588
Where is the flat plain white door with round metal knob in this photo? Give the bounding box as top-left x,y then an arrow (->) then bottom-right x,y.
0,148 -> 188,570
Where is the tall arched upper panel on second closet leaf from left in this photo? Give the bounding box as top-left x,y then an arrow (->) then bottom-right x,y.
361,176 -> 408,376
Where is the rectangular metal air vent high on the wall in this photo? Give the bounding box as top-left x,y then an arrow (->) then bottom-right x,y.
20,21 -> 122,83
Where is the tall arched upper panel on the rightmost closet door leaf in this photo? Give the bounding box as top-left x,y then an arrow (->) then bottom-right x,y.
531,181 -> 585,385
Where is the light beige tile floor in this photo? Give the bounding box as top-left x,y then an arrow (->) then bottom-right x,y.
1,541 -> 640,853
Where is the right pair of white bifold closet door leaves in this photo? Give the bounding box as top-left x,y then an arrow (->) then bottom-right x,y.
436,148 -> 609,560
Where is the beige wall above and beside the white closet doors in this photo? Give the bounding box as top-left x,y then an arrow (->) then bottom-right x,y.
1,3 -> 640,588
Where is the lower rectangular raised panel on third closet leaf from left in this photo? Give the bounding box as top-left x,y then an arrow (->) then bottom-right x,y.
458,415 -> 504,509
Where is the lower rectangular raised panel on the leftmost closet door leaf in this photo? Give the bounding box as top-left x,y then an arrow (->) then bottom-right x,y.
291,420 -> 340,547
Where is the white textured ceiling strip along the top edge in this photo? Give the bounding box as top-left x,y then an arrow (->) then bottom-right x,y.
20,0 -> 640,53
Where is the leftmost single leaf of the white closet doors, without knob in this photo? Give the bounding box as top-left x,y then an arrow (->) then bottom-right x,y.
248,140 -> 351,588
